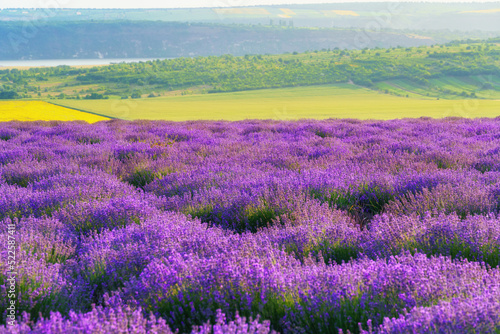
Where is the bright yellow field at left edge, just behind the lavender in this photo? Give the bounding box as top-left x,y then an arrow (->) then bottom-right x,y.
0,101 -> 109,123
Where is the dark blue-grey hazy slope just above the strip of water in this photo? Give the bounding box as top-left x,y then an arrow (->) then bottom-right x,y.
0,21 -> 448,60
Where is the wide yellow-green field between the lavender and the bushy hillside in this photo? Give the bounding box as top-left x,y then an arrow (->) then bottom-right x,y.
51,84 -> 500,121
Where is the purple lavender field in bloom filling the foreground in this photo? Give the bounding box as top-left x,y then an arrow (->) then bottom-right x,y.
0,118 -> 500,333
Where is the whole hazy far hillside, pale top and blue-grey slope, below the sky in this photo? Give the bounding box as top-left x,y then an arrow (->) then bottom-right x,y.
0,2 -> 500,61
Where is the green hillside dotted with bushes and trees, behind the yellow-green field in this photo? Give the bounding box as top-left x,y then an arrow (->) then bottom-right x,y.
0,39 -> 500,99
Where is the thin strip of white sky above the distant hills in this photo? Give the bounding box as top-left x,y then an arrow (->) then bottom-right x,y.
0,0 -> 498,8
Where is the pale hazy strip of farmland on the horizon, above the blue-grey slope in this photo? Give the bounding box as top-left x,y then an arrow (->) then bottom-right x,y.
0,1 -> 500,30
